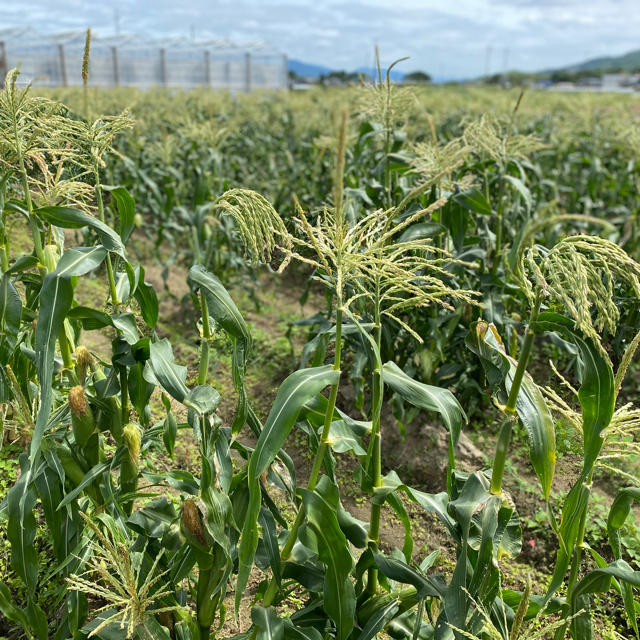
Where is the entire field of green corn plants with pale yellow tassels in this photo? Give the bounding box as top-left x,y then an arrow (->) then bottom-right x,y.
0,36 -> 640,640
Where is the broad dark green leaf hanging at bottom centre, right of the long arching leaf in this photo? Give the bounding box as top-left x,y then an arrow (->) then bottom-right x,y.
300,489 -> 356,640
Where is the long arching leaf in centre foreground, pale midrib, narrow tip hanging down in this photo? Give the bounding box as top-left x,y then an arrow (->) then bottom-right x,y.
235,365 -> 340,614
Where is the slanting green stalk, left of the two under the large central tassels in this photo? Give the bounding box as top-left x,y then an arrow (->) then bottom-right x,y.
262,300 -> 342,607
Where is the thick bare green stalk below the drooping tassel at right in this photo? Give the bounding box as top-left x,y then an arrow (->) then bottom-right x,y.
491,293 -> 542,495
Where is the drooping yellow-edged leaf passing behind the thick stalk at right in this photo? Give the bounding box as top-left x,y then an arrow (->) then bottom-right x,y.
467,322 -> 556,500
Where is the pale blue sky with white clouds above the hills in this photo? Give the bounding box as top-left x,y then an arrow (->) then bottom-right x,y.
0,0 -> 640,78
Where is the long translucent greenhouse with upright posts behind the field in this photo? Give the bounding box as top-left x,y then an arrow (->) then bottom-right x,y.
0,28 -> 288,93
